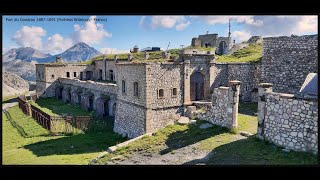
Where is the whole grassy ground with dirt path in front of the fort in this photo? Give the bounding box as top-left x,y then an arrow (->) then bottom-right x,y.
2,98 -> 317,165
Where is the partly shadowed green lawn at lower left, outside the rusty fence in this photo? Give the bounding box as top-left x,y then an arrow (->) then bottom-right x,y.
2,104 -> 125,165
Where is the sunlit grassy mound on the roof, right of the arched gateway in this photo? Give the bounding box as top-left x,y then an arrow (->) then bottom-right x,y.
216,44 -> 262,63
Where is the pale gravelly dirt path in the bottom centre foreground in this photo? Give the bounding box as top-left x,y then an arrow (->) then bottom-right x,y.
106,135 -> 246,165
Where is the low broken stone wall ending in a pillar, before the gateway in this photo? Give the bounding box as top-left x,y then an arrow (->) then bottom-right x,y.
190,81 -> 240,128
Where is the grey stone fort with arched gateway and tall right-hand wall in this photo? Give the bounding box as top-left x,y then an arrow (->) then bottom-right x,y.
36,35 -> 318,143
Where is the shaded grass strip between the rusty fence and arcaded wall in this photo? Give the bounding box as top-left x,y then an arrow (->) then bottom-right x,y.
31,98 -> 95,116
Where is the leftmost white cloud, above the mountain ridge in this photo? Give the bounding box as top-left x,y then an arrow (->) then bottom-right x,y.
12,26 -> 46,49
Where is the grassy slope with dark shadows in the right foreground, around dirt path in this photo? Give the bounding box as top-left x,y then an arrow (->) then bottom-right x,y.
97,104 -> 317,165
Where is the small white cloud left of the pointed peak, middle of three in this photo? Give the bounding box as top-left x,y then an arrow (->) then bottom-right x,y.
43,34 -> 74,54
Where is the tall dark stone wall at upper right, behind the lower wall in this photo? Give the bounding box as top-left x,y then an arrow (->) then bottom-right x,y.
261,35 -> 318,94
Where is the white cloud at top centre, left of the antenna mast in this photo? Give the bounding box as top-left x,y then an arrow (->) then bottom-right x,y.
139,16 -> 191,31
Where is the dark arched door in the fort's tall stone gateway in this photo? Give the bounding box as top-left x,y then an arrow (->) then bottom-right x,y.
190,72 -> 204,101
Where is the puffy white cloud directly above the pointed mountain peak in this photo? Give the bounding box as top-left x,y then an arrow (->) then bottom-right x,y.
72,16 -> 112,45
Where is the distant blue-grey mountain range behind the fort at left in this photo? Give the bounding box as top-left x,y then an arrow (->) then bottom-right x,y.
2,42 -> 101,81
